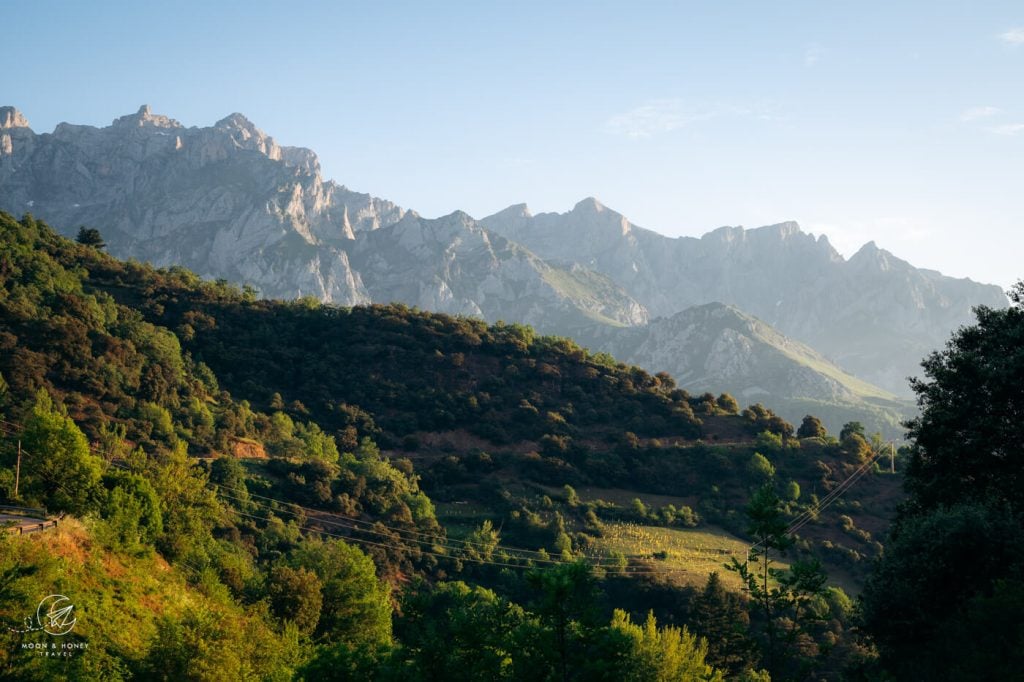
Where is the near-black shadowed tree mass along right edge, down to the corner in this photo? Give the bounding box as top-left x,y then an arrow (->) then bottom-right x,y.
863,283 -> 1024,680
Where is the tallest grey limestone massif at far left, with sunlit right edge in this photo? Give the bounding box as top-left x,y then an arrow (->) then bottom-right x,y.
0,106 -> 407,304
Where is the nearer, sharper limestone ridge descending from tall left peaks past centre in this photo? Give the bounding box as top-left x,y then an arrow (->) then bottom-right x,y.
0,106 -> 647,325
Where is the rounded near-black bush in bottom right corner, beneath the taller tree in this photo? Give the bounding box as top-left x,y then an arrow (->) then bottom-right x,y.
863,503 -> 1024,680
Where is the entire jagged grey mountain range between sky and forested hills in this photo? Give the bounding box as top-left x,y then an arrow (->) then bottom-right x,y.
0,100 -> 1006,430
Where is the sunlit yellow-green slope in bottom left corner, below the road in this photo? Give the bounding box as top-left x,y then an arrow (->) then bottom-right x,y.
0,517 -> 300,682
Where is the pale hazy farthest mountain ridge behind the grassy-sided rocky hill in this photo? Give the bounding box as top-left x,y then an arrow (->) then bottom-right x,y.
480,199 -> 1007,395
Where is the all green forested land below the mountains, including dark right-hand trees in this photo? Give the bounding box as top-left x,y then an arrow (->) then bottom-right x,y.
0,209 -> 1024,680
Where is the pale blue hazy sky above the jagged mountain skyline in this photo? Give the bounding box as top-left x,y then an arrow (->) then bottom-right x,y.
8,0 -> 1024,287
